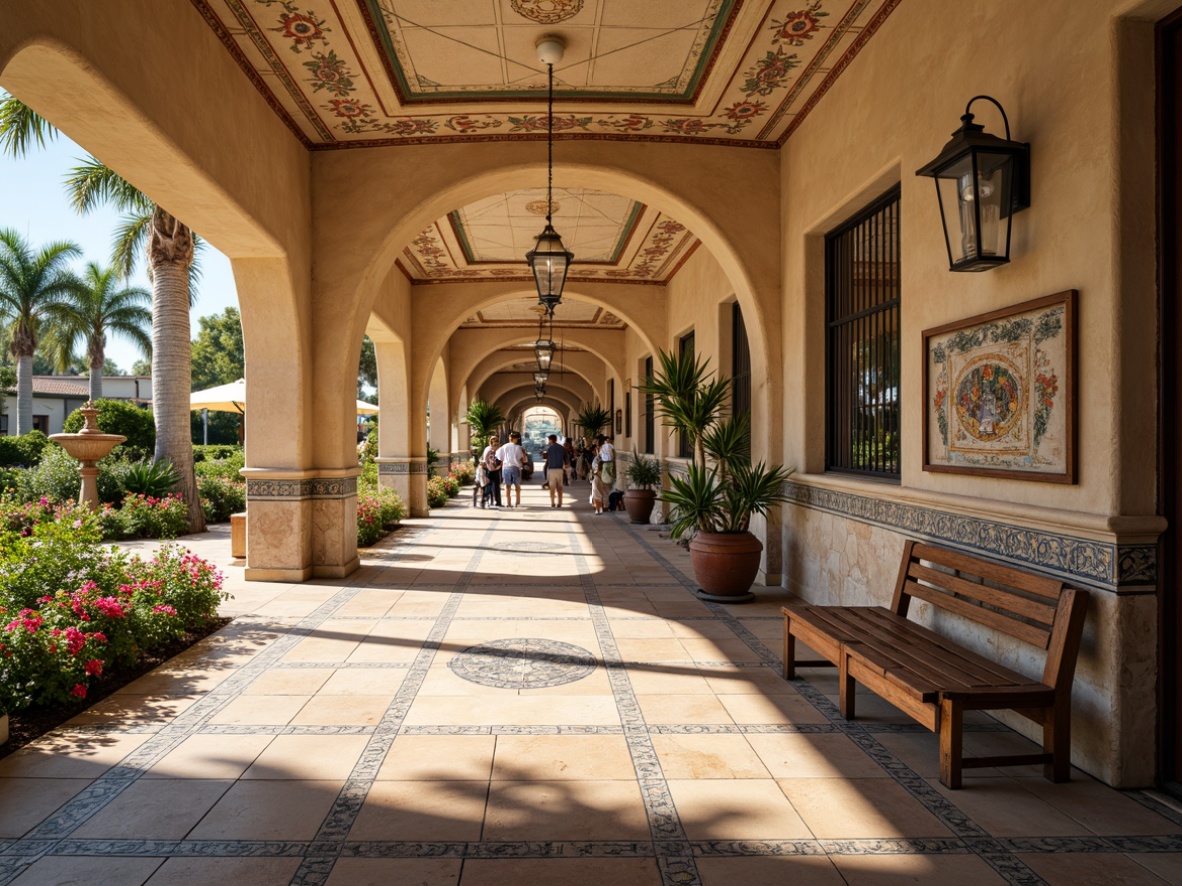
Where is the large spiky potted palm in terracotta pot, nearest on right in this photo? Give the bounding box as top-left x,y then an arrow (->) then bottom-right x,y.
639,351 -> 792,602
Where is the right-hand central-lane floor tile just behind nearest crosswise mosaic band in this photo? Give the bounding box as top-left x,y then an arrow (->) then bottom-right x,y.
483,778 -> 651,841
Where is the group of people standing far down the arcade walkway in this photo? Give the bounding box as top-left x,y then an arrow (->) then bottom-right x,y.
472,431 -> 616,514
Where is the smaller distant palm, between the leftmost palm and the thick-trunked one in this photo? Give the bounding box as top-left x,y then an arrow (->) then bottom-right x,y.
50,261 -> 151,400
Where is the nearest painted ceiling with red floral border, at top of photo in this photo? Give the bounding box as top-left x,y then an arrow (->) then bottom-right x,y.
191,0 -> 901,149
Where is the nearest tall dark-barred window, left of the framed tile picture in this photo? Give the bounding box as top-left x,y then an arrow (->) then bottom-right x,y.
825,187 -> 900,478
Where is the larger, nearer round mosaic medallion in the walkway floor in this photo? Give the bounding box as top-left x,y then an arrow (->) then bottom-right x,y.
448,637 -> 596,690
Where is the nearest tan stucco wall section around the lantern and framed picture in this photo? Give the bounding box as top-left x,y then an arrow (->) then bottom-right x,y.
780,0 -> 1160,786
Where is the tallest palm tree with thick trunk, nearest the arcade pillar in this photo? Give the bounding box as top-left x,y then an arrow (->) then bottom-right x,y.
0,96 -> 206,532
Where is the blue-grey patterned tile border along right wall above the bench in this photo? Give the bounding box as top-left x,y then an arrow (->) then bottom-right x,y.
785,481 -> 1157,594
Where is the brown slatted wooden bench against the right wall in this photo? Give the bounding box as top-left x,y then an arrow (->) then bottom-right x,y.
781,541 -> 1087,788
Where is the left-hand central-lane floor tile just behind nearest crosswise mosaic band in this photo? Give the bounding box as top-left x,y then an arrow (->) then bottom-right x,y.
349,784 -> 488,841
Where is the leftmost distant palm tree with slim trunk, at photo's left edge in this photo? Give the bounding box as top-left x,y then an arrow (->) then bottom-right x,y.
0,228 -> 82,435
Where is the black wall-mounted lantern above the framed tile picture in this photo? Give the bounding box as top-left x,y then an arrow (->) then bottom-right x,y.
916,96 -> 1031,271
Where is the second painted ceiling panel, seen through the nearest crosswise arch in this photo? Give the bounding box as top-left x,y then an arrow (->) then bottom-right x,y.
398,188 -> 699,284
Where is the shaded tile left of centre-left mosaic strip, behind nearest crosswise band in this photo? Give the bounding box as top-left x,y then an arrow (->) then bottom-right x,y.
189,780 -> 344,840
